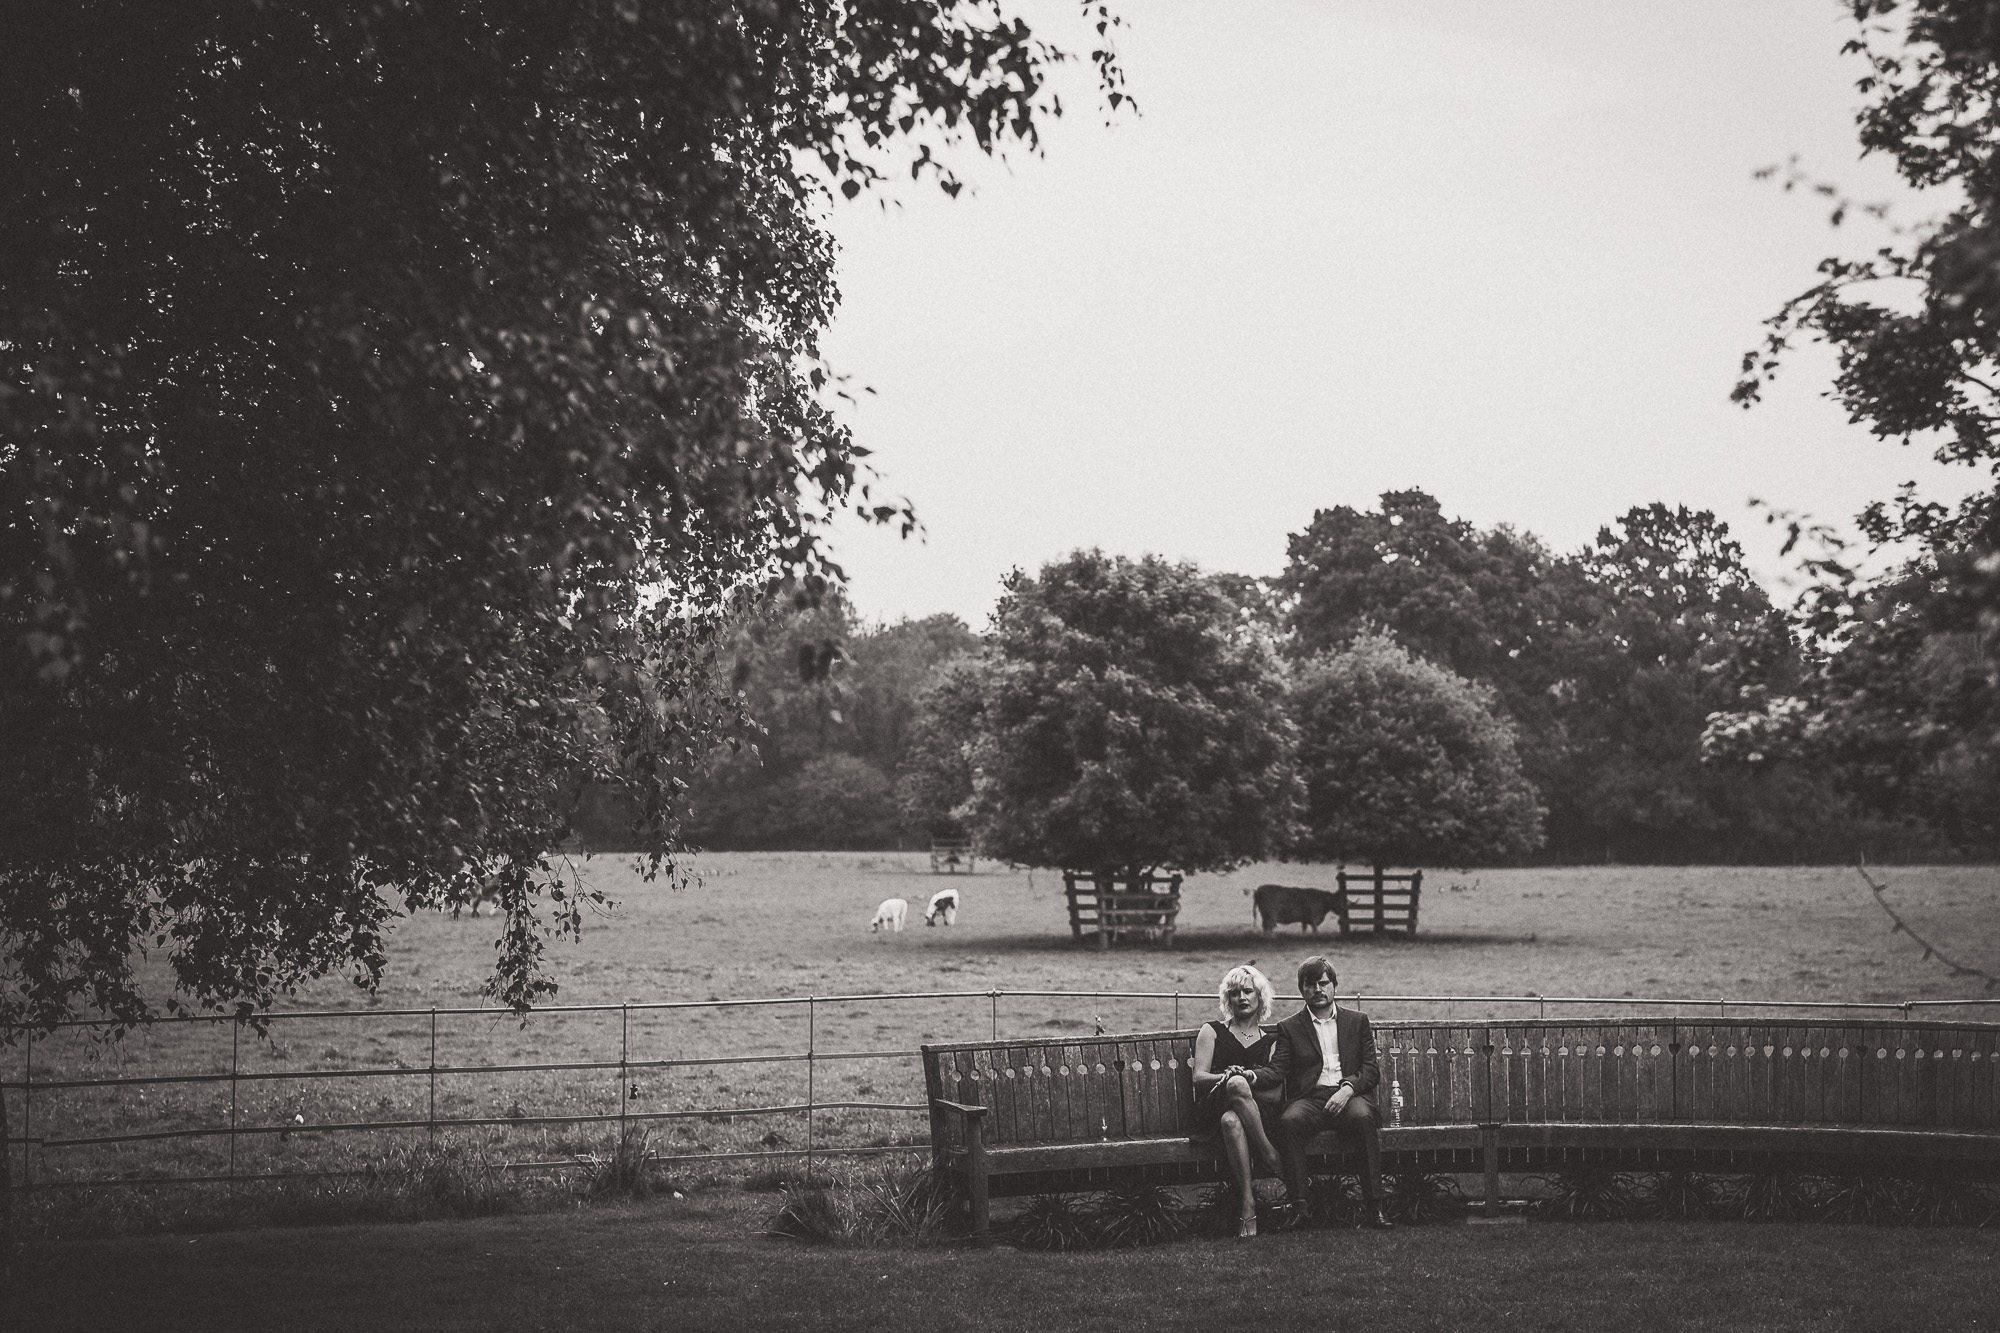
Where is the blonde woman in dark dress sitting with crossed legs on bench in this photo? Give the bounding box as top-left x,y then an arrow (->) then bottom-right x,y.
1194,965 -> 1280,1237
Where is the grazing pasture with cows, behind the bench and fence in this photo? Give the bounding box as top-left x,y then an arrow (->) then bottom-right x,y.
8,853 -> 2000,1181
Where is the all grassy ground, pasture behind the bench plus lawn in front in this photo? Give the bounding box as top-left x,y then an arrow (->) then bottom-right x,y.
15,855 -> 2000,1333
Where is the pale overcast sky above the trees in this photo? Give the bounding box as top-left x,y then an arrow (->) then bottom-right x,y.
808,0 -> 1962,628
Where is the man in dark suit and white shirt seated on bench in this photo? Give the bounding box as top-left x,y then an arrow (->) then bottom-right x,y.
1270,955 -> 1388,1229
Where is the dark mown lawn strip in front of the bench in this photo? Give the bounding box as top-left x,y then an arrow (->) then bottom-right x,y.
23,1193 -> 2000,1333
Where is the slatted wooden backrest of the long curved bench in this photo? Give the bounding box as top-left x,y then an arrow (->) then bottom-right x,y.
924,1019 -> 2000,1145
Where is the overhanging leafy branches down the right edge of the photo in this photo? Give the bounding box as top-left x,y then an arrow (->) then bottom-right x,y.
1724,0 -> 2000,820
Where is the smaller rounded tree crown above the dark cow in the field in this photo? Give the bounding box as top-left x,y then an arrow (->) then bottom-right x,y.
1292,634 -> 1542,865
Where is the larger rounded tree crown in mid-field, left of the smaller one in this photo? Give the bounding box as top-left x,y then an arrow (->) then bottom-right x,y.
972,550 -> 1300,881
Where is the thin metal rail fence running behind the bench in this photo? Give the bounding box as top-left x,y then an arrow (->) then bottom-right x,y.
0,989 -> 2000,1191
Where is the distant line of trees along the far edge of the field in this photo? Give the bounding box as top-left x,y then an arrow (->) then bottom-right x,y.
584,490 -> 2000,863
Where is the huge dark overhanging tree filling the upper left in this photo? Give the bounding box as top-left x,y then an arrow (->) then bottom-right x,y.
0,0 -> 1118,1023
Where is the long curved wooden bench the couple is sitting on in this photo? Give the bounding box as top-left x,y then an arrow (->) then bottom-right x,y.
924,1019 -> 2000,1233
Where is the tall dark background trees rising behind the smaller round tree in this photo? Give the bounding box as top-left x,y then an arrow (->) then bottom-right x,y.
1280,490 -> 1888,861
